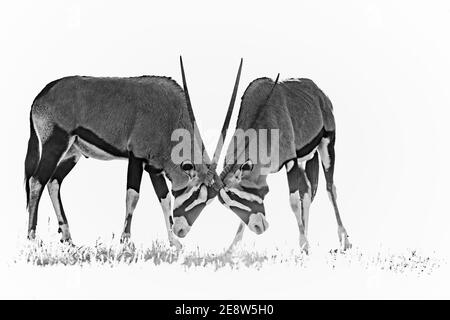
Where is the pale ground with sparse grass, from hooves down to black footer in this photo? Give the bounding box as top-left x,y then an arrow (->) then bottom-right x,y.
0,239 -> 449,299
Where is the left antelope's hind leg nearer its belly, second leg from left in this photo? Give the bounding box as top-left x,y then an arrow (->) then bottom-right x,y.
47,145 -> 81,242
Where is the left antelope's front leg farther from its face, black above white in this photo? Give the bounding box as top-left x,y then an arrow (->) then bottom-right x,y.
120,152 -> 144,242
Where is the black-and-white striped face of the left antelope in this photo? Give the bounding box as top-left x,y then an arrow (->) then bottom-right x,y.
172,161 -> 217,238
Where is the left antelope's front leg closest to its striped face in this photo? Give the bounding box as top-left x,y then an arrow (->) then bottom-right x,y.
149,166 -> 183,249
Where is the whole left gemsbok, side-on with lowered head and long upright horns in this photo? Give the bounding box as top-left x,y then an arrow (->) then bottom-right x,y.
25,57 -> 242,247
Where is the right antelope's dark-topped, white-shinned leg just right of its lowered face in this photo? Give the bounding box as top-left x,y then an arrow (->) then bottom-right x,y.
286,159 -> 311,253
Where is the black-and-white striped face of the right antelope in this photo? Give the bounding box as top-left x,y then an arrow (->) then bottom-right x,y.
219,160 -> 269,234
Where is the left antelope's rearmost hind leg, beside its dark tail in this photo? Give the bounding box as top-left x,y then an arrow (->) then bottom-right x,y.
27,128 -> 70,239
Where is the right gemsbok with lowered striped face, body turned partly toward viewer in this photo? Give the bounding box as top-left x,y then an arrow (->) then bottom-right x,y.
219,77 -> 351,252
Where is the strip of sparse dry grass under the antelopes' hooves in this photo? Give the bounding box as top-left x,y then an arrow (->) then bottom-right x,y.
15,240 -> 444,274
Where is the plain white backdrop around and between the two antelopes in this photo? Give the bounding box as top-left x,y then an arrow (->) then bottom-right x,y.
0,1 -> 450,298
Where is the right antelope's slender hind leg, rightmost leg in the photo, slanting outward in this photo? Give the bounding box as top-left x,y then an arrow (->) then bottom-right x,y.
319,132 -> 352,250
